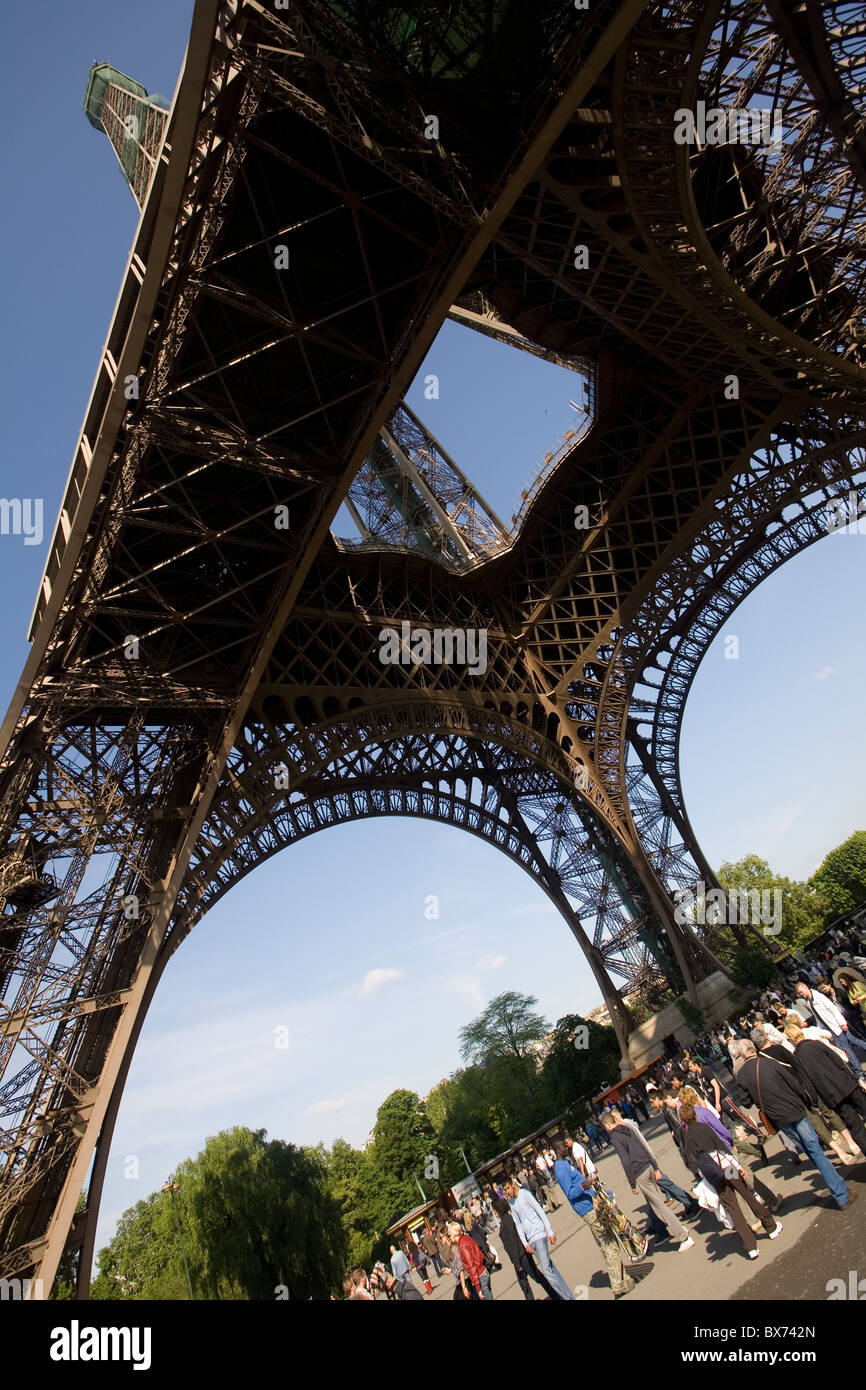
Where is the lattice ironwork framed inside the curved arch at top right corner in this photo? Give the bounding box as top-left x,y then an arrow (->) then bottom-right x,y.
691,0 -> 866,364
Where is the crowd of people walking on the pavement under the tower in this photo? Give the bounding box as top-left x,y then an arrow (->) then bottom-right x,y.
345,931 -> 866,1301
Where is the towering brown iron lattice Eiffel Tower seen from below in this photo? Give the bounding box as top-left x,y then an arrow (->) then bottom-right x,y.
0,0 -> 866,1295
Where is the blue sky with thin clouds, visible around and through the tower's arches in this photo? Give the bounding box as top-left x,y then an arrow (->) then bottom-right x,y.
0,0 -> 866,1267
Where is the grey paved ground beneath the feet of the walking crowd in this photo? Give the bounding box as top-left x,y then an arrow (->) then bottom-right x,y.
414,1115 -> 866,1304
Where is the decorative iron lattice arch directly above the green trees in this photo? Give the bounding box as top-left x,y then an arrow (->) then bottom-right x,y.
183,706 -> 706,997
